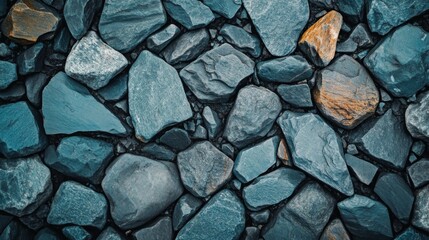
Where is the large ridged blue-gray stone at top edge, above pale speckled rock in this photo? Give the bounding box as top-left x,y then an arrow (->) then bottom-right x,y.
98,0 -> 167,52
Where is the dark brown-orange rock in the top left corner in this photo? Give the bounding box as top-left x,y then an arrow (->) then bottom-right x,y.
1,0 -> 61,44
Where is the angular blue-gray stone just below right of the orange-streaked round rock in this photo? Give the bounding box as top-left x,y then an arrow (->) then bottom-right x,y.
349,110 -> 412,169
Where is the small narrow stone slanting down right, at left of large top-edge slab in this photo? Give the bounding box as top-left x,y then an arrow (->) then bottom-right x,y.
221,23 -> 262,58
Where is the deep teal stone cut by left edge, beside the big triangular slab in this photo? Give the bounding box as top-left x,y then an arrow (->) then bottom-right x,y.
0,101 -> 47,158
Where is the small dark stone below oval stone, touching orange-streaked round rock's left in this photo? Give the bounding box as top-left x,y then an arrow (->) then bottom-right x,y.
277,83 -> 313,108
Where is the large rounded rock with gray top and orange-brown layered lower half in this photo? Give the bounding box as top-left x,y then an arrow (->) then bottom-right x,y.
313,55 -> 379,129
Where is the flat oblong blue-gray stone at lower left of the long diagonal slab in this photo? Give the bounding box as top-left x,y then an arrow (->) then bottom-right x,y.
243,167 -> 305,211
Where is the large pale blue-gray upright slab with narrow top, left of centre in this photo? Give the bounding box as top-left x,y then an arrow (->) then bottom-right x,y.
128,51 -> 192,142
